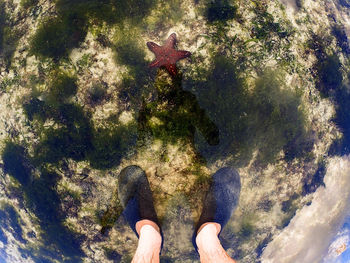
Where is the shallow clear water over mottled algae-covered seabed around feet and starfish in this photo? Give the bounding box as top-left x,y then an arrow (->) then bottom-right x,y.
0,0 -> 350,262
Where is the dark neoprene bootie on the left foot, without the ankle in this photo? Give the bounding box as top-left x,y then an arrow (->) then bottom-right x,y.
118,165 -> 163,240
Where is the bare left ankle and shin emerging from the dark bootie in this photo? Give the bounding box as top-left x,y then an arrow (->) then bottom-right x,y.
132,219 -> 162,263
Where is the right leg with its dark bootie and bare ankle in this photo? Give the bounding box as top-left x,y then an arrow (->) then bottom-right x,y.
192,167 -> 241,263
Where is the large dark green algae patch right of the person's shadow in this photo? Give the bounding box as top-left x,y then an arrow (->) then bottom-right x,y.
185,55 -> 312,165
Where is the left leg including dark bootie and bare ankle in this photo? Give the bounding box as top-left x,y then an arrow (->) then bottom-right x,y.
118,165 -> 162,263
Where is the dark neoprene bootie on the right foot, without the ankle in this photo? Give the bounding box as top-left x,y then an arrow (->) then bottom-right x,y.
192,167 -> 241,253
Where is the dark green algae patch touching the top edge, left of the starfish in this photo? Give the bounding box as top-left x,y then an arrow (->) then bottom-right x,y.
31,0 -> 155,61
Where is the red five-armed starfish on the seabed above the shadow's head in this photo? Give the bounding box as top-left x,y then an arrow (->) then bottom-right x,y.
147,33 -> 191,76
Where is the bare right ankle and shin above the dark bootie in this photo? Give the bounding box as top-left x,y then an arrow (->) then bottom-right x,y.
196,222 -> 236,263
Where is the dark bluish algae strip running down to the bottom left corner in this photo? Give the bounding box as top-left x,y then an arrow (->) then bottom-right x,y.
2,142 -> 83,262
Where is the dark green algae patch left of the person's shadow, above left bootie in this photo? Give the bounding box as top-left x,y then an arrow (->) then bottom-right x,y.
23,72 -> 136,169
